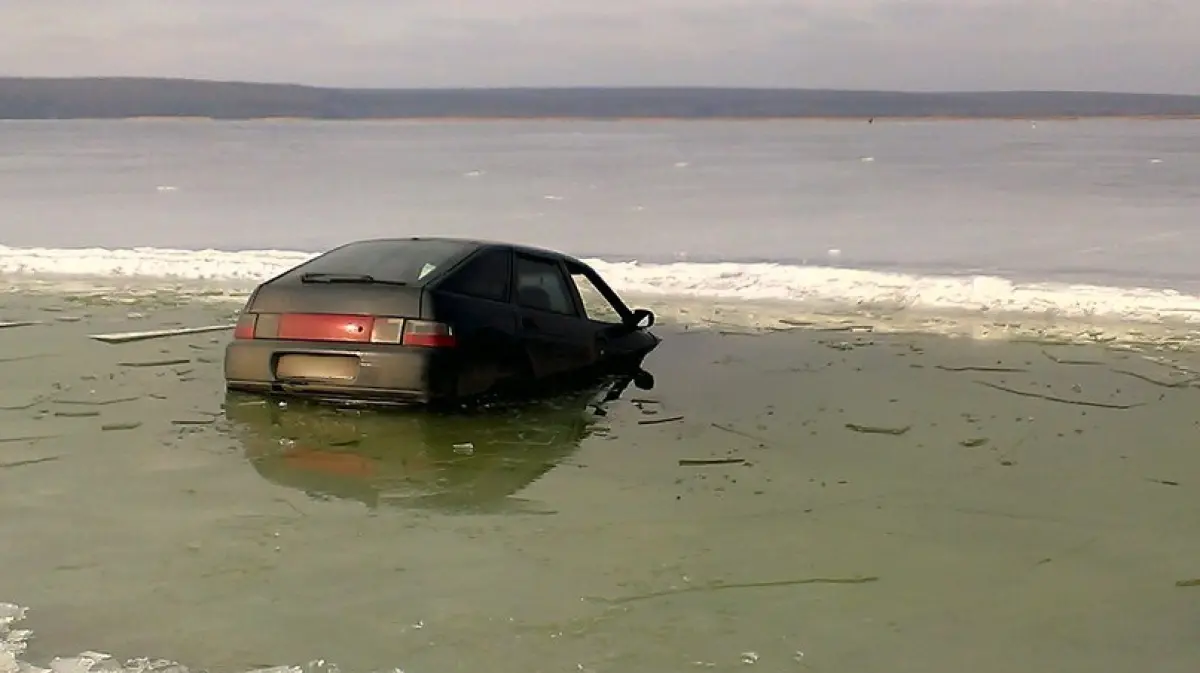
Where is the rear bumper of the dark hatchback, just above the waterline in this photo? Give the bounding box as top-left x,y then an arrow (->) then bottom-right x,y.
224,339 -> 458,403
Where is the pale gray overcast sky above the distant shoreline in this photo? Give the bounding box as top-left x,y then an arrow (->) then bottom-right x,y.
0,0 -> 1200,94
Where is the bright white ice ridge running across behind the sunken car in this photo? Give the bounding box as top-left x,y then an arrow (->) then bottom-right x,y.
0,246 -> 1200,323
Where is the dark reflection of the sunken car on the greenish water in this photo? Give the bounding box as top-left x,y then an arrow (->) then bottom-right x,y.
226,372 -> 653,511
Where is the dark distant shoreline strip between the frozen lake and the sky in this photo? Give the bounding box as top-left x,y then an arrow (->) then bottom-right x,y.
0,77 -> 1200,122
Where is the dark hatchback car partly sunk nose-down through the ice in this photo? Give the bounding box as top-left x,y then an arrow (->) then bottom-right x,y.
224,238 -> 661,404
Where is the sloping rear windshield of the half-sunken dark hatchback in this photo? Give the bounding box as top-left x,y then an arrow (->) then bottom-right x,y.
288,240 -> 473,286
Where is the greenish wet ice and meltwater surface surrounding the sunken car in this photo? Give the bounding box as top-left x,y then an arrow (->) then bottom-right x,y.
0,285 -> 1200,673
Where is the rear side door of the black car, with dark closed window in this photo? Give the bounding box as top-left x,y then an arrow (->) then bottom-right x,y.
512,252 -> 596,378
